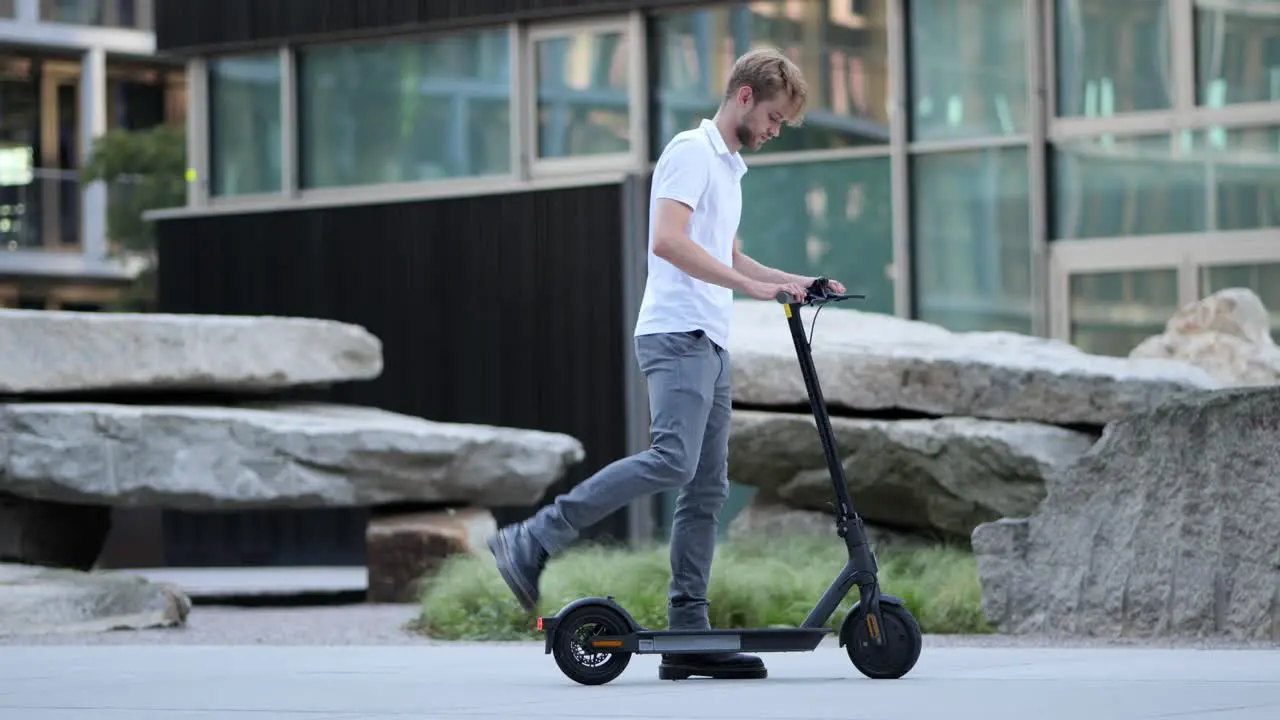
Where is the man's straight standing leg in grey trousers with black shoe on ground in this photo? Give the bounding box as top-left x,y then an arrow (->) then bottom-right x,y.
658,340 -> 767,680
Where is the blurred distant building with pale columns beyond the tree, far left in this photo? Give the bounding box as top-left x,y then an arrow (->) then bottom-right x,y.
0,0 -> 187,310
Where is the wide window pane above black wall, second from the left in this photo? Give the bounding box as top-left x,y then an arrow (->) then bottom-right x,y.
297,28 -> 511,188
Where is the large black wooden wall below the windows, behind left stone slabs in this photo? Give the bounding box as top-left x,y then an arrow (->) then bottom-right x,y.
157,186 -> 632,565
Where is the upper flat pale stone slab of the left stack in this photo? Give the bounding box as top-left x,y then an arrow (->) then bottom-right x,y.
0,304 -> 383,395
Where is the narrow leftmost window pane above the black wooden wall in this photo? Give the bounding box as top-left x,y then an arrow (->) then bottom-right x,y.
209,51 -> 283,195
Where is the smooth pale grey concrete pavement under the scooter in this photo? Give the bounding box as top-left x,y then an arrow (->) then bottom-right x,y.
0,643 -> 1280,720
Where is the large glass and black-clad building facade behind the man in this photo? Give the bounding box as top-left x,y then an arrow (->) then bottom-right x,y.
145,0 -> 1280,566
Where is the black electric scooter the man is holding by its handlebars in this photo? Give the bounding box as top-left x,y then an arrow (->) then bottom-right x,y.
538,278 -> 922,685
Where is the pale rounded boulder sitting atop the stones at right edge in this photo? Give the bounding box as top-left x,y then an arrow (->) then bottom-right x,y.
1129,288 -> 1280,387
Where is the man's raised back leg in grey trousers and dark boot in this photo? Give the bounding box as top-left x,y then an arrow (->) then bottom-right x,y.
489,332 -> 721,611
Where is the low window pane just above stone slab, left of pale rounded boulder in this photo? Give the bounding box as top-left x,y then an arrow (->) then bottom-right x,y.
1070,268 -> 1178,357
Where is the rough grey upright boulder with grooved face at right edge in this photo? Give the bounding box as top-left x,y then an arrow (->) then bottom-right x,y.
973,387 -> 1280,642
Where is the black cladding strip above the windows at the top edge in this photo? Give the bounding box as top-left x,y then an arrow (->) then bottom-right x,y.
155,0 -> 707,53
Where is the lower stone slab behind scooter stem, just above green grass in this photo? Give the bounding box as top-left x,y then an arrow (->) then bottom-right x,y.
730,410 -> 1093,541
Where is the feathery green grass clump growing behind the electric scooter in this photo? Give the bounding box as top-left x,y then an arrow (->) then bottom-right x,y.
417,537 -> 989,641
